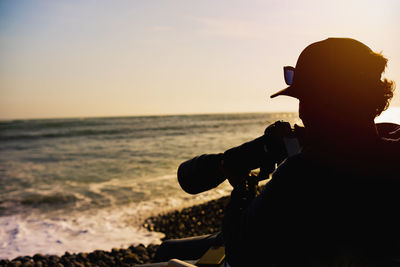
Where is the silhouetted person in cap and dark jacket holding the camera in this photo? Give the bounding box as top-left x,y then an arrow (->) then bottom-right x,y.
223,38 -> 400,266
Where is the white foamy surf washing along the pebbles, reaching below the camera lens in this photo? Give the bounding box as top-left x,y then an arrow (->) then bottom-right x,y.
0,185 -> 229,259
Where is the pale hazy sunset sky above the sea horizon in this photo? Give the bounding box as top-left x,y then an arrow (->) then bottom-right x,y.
0,0 -> 400,119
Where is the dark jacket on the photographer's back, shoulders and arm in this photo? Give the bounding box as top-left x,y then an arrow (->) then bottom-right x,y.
223,129 -> 400,266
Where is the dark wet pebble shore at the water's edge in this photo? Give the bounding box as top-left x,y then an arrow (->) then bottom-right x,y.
0,197 -> 229,267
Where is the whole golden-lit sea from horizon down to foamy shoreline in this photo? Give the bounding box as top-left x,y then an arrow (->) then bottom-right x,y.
0,113 -> 299,259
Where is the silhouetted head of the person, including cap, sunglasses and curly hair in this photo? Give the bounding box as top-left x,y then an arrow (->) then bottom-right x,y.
271,38 -> 394,126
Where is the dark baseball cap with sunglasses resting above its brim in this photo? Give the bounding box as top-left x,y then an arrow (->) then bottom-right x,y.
271,38 -> 382,99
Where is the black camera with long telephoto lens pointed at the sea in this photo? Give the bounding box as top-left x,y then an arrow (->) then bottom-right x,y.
178,121 -> 304,194
